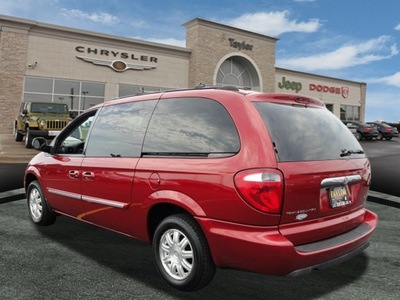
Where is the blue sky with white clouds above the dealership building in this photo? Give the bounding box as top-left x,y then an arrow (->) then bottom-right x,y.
0,0 -> 400,123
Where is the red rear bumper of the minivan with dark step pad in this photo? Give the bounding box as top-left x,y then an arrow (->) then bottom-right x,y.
198,210 -> 378,276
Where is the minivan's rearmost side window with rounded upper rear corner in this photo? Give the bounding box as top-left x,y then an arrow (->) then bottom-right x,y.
143,98 -> 240,157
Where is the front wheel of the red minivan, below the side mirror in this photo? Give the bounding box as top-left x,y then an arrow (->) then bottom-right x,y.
26,180 -> 56,226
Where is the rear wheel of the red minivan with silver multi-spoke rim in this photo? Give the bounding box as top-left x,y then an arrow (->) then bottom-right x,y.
153,214 -> 216,291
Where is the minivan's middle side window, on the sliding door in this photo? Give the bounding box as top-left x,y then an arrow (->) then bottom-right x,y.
86,100 -> 157,157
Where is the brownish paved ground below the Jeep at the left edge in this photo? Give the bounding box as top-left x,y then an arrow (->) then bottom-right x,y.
0,133 -> 38,163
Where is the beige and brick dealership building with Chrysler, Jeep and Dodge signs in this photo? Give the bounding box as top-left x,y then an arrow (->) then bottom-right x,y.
0,15 -> 366,133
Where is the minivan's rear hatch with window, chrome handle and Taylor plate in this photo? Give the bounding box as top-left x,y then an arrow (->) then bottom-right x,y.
254,97 -> 370,245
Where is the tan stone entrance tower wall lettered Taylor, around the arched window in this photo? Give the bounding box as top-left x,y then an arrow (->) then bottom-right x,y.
184,19 -> 276,92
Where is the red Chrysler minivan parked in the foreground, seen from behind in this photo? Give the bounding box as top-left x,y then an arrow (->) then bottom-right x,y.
25,87 -> 378,291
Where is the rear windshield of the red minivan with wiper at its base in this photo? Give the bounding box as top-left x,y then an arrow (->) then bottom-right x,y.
254,102 -> 365,162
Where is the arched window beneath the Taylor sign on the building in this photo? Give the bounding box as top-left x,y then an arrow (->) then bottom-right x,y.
216,56 -> 260,91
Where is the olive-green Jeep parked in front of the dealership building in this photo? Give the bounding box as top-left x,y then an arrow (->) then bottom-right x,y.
14,102 -> 72,148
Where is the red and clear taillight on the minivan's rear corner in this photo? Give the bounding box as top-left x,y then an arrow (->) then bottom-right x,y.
235,169 -> 283,214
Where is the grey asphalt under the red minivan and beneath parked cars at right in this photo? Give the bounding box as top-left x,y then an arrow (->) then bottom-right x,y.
0,135 -> 400,300
